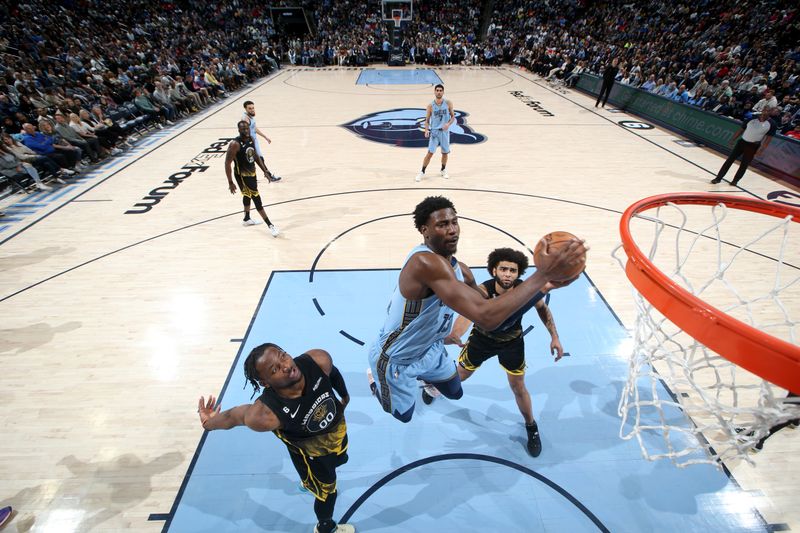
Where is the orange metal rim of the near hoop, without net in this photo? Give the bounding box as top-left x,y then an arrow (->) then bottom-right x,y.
619,193 -> 800,394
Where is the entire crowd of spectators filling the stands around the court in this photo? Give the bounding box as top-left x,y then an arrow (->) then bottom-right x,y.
0,0 -> 800,195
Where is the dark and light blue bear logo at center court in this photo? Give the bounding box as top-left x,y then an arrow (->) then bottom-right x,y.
342,108 -> 486,148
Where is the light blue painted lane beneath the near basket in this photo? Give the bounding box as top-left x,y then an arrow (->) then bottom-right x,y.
169,268 -> 765,533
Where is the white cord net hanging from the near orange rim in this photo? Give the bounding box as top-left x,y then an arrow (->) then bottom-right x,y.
612,203 -> 800,466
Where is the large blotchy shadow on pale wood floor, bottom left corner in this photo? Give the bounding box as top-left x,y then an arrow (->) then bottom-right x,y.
8,452 -> 184,531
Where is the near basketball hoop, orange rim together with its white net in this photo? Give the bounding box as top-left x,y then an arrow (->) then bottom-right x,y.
612,193 -> 800,466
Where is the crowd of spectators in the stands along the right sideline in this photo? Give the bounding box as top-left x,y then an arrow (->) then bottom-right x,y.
486,0 -> 800,137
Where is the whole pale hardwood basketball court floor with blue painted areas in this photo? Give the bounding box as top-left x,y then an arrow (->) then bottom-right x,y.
0,66 -> 800,532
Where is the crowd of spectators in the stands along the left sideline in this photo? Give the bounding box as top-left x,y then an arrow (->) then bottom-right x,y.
0,0 -> 277,188
